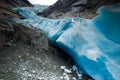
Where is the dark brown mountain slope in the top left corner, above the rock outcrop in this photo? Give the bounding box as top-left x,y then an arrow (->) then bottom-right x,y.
0,0 -> 32,18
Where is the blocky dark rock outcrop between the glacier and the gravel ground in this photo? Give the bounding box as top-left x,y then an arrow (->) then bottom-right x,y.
0,19 -> 48,49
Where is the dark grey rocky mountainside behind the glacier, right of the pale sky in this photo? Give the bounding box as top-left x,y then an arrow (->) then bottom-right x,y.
40,0 -> 118,17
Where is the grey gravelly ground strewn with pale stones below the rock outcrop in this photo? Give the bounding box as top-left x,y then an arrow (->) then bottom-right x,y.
0,43 -> 75,80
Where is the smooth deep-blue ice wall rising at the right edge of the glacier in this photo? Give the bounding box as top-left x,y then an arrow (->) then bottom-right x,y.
93,4 -> 120,44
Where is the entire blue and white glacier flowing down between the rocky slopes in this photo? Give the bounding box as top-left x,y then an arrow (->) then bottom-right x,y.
14,4 -> 120,80
